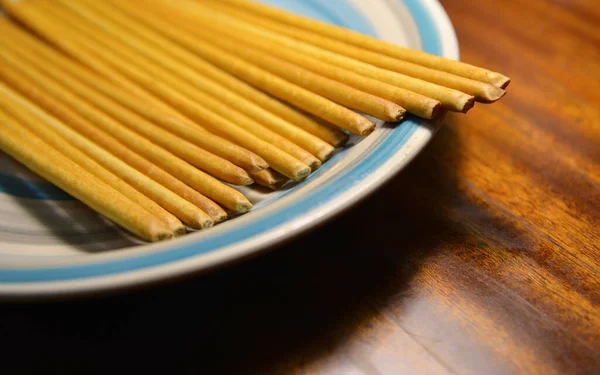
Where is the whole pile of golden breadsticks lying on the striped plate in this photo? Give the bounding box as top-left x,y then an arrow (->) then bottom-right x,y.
0,0 -> 510,241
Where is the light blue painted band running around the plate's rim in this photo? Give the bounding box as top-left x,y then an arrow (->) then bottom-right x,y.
0,0 -> 442,283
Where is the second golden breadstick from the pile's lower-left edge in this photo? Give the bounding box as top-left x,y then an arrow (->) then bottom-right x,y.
0,94 -> 186,235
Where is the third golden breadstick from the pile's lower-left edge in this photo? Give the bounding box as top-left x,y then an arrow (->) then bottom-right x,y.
0,80 -> 213,229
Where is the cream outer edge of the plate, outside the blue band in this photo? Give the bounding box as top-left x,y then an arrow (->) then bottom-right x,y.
0,0 -> 459,299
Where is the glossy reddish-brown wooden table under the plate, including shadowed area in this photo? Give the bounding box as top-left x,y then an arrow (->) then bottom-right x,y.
0,0 -> 600,375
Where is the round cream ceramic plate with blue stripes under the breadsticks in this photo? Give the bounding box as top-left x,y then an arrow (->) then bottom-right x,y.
0,0 -> 458,297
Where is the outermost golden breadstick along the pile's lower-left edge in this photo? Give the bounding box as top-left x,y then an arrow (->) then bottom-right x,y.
0,111 -> 173,241
